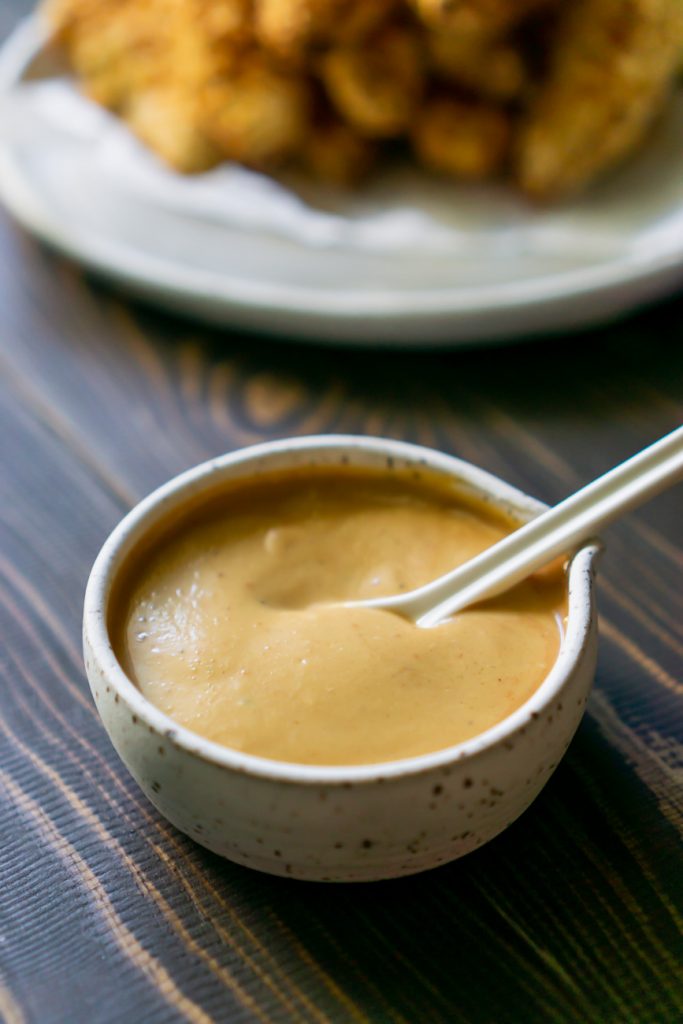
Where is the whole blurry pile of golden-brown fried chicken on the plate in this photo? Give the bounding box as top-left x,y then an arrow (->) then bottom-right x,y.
46,0 -> 683,195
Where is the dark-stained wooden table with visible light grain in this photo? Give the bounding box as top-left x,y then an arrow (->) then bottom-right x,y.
0,0 -> 683,1024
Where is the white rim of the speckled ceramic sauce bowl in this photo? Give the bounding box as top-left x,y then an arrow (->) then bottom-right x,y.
83,434 -> 602,785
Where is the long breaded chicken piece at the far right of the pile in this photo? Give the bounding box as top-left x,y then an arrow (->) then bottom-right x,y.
516,0 -> 683,201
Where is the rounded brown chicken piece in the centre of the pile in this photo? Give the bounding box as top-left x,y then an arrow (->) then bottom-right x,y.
321,27 -> 424,138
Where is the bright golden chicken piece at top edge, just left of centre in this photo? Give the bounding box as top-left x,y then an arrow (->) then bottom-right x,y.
254,0 -> 397,65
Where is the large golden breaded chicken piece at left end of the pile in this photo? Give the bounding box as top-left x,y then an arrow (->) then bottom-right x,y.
50,0 -> 309,172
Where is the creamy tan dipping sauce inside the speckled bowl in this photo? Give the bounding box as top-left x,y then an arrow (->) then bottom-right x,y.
110,468 -> 566,765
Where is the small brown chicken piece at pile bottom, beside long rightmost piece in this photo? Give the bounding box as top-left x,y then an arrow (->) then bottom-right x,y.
412,96 -> 512,180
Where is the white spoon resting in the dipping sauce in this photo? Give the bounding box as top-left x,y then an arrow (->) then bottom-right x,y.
347,427 -> 683,627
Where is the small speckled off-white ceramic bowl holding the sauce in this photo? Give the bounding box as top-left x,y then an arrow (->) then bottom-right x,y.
83,436 -> 598,882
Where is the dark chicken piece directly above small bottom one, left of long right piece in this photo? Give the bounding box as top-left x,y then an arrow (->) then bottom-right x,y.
426,31 -> 529,100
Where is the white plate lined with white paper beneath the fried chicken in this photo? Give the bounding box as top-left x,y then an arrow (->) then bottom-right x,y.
0,19 -> 683,346
